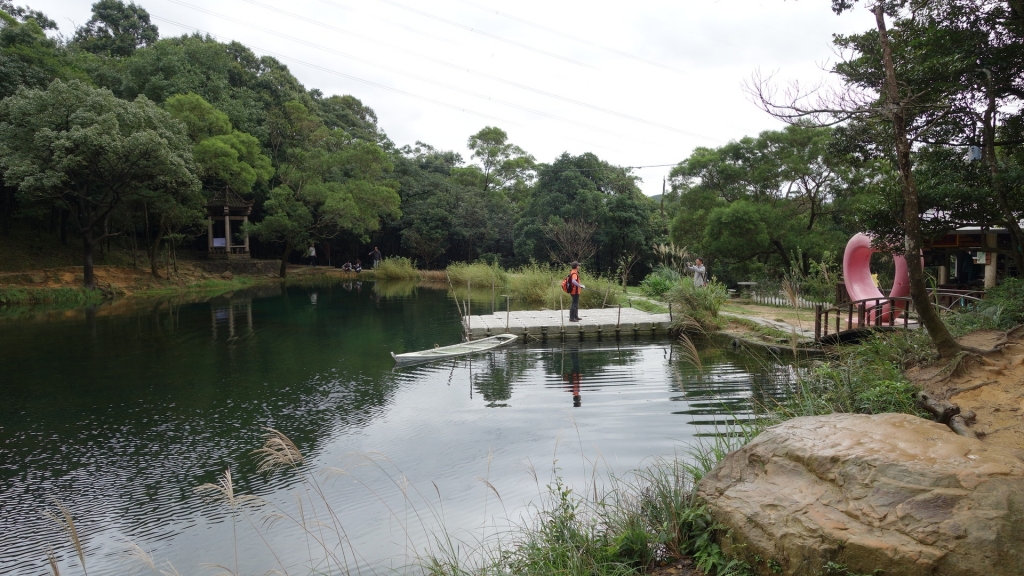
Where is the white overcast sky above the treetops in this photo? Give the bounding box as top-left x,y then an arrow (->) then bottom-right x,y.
34,0 -> 873,195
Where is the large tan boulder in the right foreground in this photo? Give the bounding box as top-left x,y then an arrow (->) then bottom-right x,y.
697,414 -> 1024,576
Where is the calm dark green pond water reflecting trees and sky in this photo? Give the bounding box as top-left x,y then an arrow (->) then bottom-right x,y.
0,283 -> 792,576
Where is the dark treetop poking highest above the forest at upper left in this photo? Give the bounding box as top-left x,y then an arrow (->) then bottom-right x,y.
74,0 -> 160,57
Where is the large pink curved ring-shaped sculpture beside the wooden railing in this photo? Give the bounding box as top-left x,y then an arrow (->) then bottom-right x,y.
843,234 -> 910,324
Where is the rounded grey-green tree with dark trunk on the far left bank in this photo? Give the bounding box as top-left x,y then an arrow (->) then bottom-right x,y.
0,80 -> 199,288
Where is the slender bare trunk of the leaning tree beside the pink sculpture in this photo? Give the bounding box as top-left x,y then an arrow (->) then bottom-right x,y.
874,3 -> 964,358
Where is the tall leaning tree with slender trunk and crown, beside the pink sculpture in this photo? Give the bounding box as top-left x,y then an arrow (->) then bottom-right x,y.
753,0 -> 1024,357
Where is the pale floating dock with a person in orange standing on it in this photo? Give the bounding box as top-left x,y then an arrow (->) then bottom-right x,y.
462,307 -> 672,340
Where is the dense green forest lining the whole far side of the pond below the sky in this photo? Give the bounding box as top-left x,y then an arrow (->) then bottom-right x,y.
0,0 -> 1024,283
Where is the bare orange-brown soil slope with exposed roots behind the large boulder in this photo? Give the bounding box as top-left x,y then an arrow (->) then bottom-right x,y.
906,327 -> 1024,453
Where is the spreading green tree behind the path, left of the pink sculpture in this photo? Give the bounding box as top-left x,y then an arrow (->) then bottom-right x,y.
671,124 -> 850,280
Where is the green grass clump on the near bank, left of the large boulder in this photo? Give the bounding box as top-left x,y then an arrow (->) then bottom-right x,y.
422,426 -> 759,576
